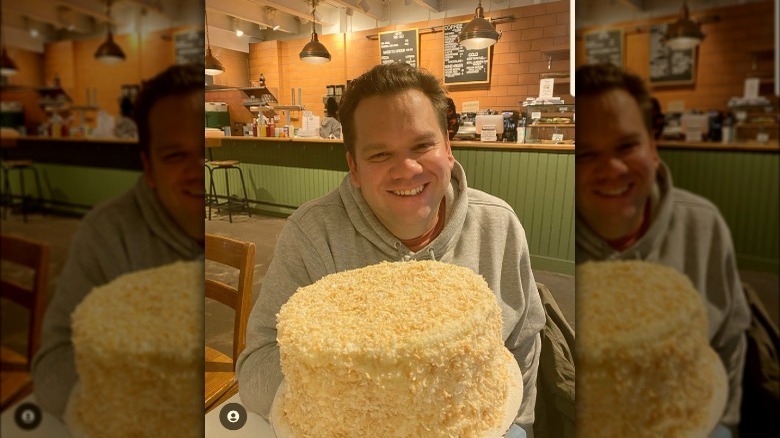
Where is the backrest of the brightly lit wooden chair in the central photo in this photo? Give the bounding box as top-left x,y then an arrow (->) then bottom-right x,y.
205,233 -> 255,370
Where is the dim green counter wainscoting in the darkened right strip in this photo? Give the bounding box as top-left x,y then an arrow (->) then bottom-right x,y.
659,148 -> 780,273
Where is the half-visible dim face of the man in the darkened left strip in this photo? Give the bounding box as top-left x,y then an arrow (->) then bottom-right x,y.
141,93 -> 205,241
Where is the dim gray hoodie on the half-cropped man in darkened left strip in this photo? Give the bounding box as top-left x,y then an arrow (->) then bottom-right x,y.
32,177 -> 203,417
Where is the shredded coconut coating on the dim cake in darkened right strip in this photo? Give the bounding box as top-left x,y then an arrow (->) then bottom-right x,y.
576,261 -> 714,438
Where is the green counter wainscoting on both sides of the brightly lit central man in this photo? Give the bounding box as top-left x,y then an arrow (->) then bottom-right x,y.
209,139 -> 574,275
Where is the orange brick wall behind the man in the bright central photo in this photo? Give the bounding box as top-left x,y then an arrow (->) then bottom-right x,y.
206,0 -> 572,125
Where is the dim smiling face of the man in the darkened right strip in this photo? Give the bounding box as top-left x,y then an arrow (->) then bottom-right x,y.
575,89 -> 659,240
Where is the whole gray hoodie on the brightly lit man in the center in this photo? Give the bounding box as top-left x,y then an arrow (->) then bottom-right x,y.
237,163 -> 545,427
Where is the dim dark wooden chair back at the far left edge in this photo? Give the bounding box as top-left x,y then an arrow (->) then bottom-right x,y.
0,234 -> 50,366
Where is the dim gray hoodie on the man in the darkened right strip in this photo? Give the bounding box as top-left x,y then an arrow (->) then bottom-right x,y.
575,163 -> 750,425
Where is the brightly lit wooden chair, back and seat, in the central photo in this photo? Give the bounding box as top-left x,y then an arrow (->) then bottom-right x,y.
205,233 -> 255,412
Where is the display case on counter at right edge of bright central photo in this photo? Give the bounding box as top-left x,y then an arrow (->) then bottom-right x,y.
524,104 -> 575,144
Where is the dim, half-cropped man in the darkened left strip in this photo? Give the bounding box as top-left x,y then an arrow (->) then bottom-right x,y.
32,65 -> 204,417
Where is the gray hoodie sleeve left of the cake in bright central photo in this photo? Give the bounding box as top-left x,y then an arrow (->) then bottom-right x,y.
236,219 -> 321,419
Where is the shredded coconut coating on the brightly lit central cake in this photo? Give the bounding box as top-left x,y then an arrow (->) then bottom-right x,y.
277,261 -> 511,437
